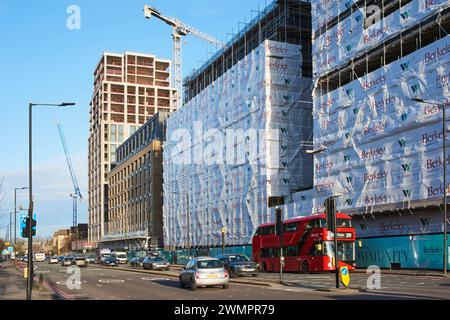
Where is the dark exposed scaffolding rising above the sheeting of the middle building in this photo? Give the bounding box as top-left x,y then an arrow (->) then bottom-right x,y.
184,0 -> 312,103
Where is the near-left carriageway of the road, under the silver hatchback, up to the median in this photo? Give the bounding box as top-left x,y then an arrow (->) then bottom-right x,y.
32,264 -> 331,300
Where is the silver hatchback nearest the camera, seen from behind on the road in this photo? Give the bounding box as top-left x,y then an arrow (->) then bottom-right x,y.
179,257 -> 230,291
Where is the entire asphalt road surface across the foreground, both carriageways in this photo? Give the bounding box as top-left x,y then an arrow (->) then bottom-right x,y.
14,263 -> 450,300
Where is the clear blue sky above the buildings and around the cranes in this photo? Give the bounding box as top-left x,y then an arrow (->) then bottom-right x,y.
0,0 -> 271,238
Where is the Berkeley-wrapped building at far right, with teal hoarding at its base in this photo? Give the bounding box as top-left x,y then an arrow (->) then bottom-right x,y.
302,0 -> 450,270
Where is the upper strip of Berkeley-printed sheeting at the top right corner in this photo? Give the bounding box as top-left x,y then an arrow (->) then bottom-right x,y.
312,0 -> 450,77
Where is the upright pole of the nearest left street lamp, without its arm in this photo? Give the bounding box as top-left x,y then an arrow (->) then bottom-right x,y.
26,103 -> 33,300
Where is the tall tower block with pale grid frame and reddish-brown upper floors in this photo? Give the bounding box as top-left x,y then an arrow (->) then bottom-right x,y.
88,52 -> 177,243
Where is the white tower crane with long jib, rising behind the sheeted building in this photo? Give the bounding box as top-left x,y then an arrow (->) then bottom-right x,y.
144,5 -> 225,107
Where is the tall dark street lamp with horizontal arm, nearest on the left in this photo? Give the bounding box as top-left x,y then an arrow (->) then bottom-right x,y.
27,102 -> 75,300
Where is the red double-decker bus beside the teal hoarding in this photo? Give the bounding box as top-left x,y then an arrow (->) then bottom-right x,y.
252,213 -> 356,273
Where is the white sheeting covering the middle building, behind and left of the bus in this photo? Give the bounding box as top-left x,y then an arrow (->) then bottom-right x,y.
163,41 -> 312,247
